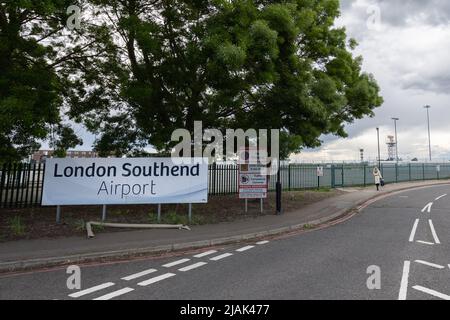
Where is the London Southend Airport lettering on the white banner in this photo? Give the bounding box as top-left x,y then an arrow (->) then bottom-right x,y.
53,162 -> 200,199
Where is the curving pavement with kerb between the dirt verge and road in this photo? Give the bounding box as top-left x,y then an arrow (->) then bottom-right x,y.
0,180 -> 450,272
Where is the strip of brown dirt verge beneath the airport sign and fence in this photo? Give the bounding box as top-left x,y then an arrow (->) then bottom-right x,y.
0,189 -> 343,242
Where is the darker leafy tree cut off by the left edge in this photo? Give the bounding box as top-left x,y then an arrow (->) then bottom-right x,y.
0,0 -> 81,162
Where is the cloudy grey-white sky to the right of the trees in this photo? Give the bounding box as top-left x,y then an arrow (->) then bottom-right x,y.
295,0 -> 450,161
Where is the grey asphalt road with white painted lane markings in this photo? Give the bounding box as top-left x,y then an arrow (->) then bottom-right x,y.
0,186 -> 450,300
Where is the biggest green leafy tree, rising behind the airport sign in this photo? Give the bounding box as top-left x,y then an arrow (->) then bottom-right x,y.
71,0 -> 382,157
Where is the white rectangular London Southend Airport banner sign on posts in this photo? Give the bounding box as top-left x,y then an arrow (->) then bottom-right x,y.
42,158 -> 208,206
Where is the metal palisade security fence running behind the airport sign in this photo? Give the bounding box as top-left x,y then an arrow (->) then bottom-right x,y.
0,163 -> 450,208
